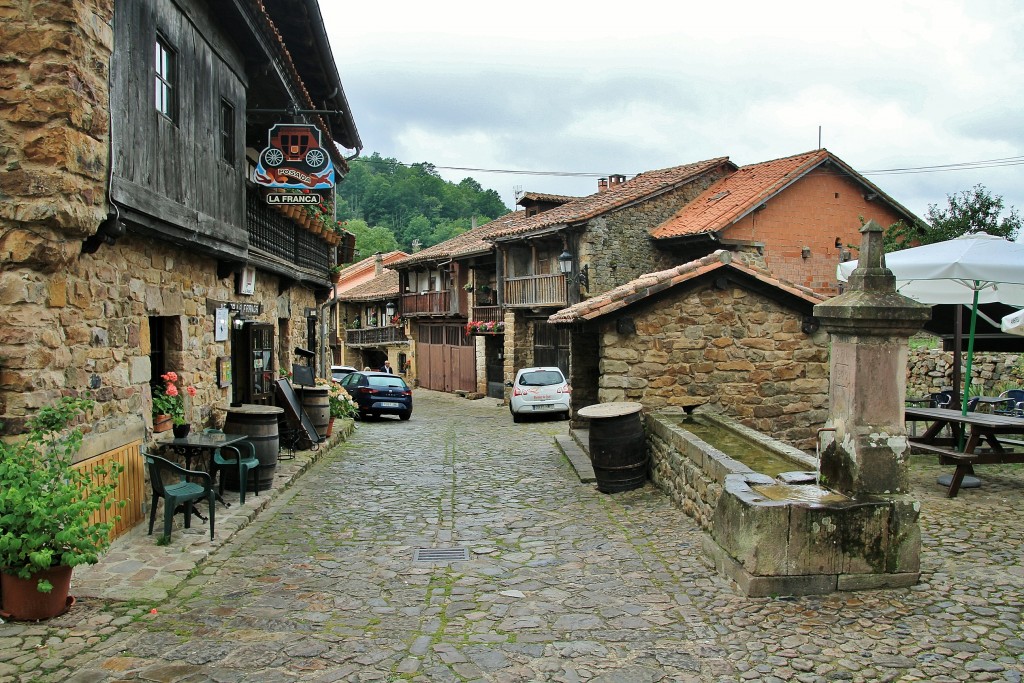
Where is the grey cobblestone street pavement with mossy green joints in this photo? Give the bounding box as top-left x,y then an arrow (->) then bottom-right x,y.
0,390 -> 1024,683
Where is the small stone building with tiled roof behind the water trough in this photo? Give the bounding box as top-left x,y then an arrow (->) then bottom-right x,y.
549,251 -> 828,451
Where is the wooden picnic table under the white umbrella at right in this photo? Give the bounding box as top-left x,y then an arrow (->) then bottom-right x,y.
904,407 -> 1024,498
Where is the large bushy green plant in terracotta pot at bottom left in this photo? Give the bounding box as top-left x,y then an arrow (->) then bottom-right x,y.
0,396 -> 125,620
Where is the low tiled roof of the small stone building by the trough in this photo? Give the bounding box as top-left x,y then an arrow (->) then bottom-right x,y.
548,250 -> 825,323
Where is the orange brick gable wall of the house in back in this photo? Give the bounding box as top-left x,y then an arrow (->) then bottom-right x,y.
723,166 -> 899,295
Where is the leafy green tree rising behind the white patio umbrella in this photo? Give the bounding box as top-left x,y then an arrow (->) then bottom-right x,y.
885,184 -> 1021,252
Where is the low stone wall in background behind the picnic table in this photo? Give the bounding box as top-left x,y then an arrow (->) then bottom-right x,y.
906,349 -> 1024,396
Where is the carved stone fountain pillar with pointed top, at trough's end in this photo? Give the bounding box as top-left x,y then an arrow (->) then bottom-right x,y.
814,221 -> 931,498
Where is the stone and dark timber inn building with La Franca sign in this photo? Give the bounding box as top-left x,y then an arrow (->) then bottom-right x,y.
0,0 -> 361,532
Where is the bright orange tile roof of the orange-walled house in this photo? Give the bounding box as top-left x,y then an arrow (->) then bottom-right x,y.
651,148 -> 915,240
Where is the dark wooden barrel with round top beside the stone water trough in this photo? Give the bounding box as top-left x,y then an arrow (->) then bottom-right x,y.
578,401 -> 647,494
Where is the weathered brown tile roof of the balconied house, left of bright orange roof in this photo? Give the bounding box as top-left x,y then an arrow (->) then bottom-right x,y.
488,157 -> 736,239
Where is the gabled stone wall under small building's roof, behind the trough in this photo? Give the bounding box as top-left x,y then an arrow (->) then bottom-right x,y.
599,286 -> 828,451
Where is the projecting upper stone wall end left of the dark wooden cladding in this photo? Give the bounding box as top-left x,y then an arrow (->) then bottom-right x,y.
0,0 -> 114,270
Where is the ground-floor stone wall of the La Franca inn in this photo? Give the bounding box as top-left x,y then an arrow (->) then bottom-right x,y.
0,236 -> 315,455
